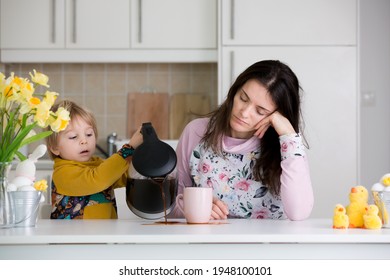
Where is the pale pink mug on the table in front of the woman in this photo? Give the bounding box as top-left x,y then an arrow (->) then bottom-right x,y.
176,187 -> 213,224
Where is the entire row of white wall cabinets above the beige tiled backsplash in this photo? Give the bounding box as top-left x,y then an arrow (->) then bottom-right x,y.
0,0 -> 218,63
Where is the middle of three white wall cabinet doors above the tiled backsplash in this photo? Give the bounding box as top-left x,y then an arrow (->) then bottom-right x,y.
66,0 -> 130,49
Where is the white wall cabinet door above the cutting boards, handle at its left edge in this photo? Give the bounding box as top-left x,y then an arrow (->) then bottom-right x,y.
131,0 -> 217,49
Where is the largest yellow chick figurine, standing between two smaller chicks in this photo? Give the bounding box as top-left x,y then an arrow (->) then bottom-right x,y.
346,186 -> 368,228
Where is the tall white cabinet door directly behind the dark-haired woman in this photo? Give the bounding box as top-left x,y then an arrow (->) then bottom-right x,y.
219,46 -> 358,217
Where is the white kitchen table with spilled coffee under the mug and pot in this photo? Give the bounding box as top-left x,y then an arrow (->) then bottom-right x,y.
0,219 -> 390,260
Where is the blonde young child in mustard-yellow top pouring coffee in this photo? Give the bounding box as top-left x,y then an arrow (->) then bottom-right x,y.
46,100 -> 143,219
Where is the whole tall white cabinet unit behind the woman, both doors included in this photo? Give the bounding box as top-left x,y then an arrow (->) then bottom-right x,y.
218,0 -> 359,218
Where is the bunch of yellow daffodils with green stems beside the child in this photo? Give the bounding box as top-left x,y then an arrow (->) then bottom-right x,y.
0,69 -> 70,162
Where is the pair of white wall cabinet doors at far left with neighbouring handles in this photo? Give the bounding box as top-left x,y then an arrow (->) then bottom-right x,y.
1,0 -> 130,49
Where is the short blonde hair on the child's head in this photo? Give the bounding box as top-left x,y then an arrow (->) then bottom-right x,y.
46,100 -> 98,159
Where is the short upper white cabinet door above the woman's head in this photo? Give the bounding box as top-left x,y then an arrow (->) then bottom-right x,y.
221,0 -> 357,45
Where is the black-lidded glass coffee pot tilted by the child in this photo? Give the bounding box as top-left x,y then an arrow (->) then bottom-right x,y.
126,122 -> 177,219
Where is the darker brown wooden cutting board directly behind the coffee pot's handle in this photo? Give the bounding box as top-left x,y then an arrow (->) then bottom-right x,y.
127,92 -> 169,139
